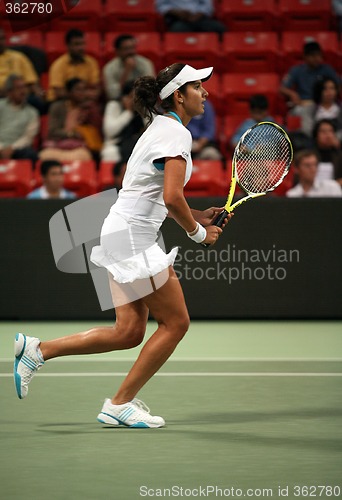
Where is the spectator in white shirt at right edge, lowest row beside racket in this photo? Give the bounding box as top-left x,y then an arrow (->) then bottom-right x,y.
286,149 -> 342,198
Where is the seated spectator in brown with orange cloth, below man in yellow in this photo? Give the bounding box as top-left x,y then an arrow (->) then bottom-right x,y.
39,78 -> 102,162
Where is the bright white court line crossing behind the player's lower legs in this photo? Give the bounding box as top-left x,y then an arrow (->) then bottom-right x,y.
0,372 -> 342,378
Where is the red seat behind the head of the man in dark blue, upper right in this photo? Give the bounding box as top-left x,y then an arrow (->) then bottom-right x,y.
280,31 -> 342,73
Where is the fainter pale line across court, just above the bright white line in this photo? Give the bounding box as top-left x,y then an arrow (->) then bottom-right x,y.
0,355 -> 342,363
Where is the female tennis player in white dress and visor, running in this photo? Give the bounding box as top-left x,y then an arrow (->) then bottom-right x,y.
14,63 -> 231,428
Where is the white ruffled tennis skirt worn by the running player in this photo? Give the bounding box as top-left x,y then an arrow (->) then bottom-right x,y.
90,211 -> 178,283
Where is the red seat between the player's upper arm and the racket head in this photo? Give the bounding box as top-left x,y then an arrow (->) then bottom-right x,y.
184,160 -> 227,196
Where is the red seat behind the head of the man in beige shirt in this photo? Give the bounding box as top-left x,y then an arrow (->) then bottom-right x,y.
104,32 -> 163,71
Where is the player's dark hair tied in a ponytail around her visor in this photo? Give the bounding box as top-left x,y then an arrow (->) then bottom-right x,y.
134,63 -> 186,124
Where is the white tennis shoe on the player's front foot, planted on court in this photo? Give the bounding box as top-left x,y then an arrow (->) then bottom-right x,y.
97,398 -> 165,428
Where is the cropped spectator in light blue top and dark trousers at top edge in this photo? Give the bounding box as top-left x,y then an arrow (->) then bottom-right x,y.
156,0 -> 226,34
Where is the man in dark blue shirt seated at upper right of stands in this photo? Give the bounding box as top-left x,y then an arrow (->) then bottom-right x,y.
280,41 -> 340,116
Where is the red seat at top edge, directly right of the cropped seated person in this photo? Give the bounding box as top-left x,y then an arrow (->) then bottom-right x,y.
217,0 -> 277,31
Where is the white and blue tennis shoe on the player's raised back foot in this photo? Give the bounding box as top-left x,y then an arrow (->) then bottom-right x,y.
14,333 -> 44,399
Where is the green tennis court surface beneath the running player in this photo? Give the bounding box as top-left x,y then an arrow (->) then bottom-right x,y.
0,321 -> 342,500
